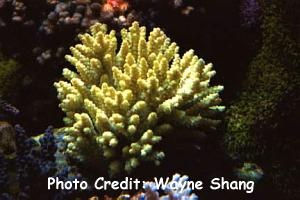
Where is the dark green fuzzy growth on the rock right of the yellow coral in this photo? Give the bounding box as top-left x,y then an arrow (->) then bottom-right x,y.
225,0 -> 299,159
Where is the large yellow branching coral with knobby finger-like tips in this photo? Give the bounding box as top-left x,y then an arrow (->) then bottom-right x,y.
54,22 -> 224,175
